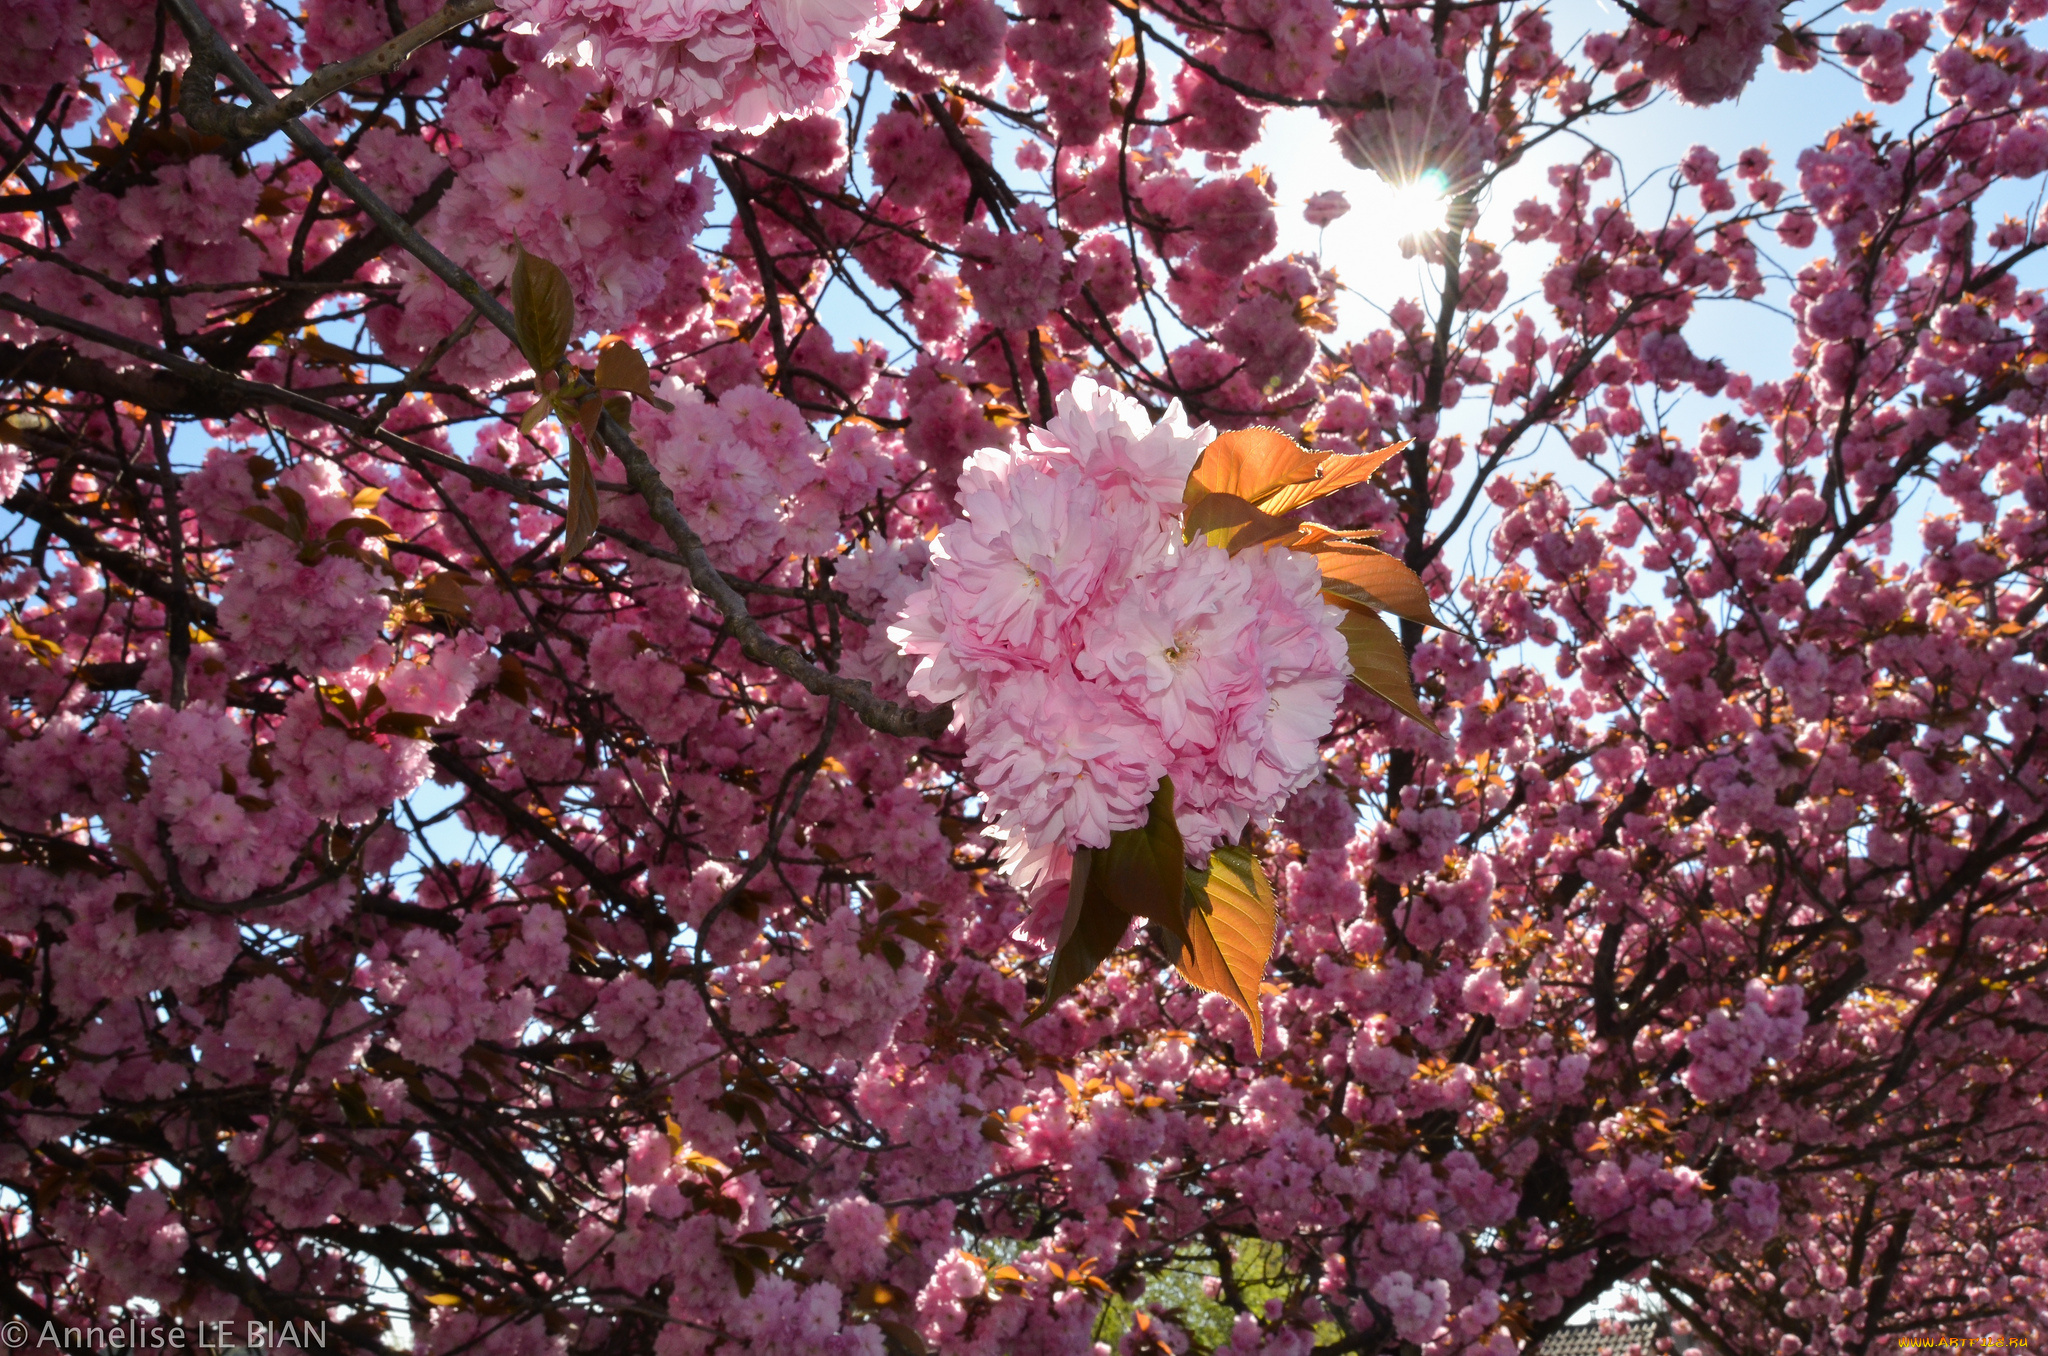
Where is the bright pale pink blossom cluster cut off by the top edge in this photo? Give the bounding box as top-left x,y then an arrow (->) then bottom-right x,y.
506,0 -> 903,131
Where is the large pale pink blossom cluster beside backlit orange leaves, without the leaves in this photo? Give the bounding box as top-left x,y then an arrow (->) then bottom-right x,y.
889,377 -> 1350,887
